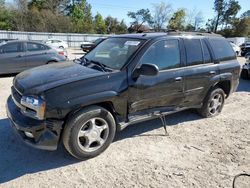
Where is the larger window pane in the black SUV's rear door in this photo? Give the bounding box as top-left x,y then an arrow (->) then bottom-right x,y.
184,39 -> 203,66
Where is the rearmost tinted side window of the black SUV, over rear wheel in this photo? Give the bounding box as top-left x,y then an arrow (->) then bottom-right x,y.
210,39 -> 236,61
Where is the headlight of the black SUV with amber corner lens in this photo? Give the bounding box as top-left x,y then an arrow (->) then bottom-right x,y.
21,96 -> 46,120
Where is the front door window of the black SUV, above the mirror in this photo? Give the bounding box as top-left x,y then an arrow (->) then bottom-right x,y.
140,40 -> 180,70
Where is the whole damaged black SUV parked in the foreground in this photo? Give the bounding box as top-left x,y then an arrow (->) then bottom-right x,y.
7,32 -> 240,159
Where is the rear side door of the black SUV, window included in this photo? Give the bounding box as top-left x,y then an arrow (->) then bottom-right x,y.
184,38 -> 219,107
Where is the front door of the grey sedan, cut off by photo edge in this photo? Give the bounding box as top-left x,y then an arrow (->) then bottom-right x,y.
0,42 -> 26,74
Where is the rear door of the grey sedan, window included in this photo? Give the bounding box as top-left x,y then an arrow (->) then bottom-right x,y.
25,42 -> 50,68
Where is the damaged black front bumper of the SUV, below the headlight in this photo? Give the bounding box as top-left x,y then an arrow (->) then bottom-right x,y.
6,96 -> 63,150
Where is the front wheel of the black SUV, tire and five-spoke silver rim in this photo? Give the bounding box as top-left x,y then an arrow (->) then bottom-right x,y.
62,106 -> 116,160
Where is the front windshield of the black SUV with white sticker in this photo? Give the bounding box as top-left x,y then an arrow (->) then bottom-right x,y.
84,38 -> 143,70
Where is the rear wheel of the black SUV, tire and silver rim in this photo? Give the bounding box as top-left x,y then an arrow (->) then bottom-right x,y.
198,88 -> 225,118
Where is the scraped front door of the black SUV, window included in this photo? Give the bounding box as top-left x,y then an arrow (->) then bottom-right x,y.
129,39 -> 184,114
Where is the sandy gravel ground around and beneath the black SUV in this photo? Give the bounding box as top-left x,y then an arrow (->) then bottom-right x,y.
0,54 -> 250,188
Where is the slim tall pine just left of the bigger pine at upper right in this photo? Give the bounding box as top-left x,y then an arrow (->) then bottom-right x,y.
214,0 -> 226,32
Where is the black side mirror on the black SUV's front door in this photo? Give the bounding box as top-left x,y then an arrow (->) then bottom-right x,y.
133,64 -> 159,78
